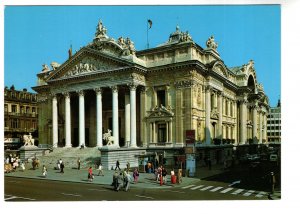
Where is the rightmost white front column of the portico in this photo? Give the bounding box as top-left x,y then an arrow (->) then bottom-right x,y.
130,85 -> 137,147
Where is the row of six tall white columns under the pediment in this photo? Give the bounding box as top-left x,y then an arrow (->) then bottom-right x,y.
52,84 -> 137,148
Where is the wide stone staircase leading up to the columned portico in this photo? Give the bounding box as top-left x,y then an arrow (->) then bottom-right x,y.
38,147 -> 101,168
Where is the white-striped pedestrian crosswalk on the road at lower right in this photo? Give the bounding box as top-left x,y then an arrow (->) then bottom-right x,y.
181,184 -> 268,198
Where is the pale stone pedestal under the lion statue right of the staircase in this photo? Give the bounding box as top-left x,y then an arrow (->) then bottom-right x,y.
99,146 -> 146,170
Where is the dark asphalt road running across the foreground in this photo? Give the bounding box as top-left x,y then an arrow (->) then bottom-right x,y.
4,177 -> 266,202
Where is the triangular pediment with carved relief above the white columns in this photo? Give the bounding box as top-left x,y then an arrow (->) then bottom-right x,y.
46,48 -> 133,81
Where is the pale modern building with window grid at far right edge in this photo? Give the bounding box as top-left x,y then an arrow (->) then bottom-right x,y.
267,100 -> 281,143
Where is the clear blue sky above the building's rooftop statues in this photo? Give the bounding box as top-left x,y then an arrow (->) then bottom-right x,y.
4,5 -> 281,106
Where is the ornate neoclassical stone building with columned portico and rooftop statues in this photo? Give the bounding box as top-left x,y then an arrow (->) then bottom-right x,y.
33,21 -> 269,164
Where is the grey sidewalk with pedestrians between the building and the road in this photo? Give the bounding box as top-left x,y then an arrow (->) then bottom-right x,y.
5,165 -> 204,189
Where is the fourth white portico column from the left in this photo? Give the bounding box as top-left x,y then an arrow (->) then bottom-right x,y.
95,88 -> 103,147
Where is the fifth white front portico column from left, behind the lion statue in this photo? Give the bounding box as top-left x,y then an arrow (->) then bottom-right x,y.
111,86 -> 119,147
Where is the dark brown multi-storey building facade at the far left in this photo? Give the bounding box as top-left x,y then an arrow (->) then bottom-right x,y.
4,86 -> 38,148
